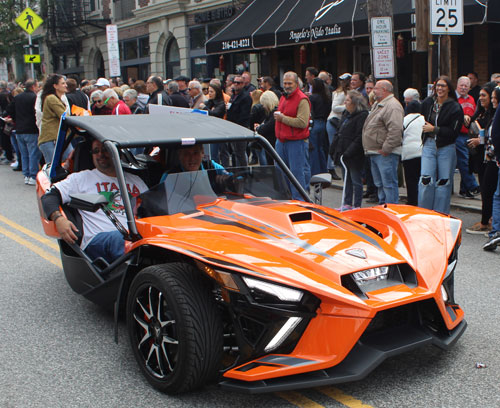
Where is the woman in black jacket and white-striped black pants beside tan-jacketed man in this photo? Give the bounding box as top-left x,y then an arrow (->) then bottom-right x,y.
330,91 -> 368,211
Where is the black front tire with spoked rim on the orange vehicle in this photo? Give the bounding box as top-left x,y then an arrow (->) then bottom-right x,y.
127,263 -> 223,394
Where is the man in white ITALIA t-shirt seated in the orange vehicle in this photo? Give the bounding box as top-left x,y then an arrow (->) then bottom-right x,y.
42,140 -> 148,263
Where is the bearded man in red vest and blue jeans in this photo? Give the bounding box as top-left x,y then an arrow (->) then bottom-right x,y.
274,72 -> 311,200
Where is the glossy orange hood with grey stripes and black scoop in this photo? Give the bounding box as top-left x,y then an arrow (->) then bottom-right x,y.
135,199 -> 454,302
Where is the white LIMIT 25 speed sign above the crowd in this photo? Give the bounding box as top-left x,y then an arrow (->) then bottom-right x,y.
429,0 -> 464,35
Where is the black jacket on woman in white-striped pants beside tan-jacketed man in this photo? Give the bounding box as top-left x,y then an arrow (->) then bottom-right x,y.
330,110 -> 368,163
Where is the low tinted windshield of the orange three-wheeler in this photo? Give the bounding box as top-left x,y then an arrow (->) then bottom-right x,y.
135,166 -> 291,218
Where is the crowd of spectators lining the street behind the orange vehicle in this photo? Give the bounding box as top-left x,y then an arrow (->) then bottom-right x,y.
0,67 -> 500,249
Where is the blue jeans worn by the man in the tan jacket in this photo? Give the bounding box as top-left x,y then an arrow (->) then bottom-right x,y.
370,153 -> 400,204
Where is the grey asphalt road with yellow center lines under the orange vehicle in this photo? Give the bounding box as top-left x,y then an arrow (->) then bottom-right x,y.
0,166 -> 500,408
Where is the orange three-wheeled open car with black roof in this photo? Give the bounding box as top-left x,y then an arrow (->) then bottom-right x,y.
37,114 -> 466,393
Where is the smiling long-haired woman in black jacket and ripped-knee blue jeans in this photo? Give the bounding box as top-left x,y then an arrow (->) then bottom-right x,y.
418,76 -> 464,214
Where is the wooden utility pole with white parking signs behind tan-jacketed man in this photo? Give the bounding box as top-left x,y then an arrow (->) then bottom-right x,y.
367,0 -> 398,95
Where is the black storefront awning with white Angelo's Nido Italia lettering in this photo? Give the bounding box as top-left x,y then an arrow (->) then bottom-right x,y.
206,0 -> 500,54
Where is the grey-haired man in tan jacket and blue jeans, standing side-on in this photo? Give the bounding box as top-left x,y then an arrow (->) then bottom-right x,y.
363,80 -> 404,204
